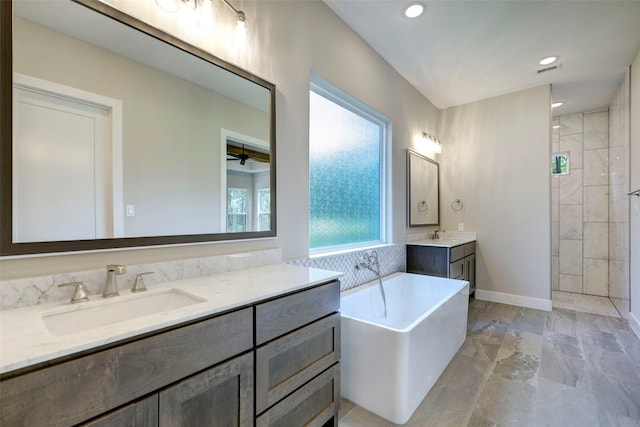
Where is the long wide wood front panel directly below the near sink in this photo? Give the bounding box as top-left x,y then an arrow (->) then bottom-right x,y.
0,308 -> 253,427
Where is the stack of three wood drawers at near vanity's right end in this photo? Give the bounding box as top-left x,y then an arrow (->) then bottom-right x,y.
256,281 -> 340,427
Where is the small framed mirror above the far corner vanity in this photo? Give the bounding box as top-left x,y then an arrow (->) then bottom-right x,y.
407,149 -> 440,228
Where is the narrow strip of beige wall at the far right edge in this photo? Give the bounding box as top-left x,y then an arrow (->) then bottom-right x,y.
629,47 -> 640,336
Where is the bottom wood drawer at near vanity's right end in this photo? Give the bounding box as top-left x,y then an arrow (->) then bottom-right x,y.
256,364 -> 340,427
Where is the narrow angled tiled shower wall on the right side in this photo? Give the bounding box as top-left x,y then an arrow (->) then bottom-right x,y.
609,68 -> 630,315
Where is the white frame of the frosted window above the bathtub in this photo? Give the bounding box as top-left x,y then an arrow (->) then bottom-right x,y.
309,72 -> 392,256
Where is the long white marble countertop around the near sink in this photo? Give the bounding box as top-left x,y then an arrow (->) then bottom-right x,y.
0,264 -> 342,374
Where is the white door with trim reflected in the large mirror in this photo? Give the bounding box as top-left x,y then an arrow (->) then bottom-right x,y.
13,81 -> 113,242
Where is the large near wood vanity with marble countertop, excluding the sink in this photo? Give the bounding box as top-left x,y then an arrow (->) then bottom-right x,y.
0,264 -> 340,426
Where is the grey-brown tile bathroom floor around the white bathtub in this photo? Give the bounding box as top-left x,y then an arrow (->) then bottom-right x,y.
339,300 -> 640,427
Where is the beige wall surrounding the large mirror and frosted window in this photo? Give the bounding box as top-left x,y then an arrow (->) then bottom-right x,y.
0,0 -> 440,279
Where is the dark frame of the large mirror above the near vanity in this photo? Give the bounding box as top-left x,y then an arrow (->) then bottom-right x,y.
0,0 -> 277,256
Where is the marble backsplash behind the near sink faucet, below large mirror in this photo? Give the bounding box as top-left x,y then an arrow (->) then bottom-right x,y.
0,249 -> 282,310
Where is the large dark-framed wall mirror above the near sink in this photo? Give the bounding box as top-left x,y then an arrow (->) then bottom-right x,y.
0,0 -> 276,256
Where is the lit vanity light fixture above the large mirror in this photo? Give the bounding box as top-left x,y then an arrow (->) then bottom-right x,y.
156,0 -> 247,49
